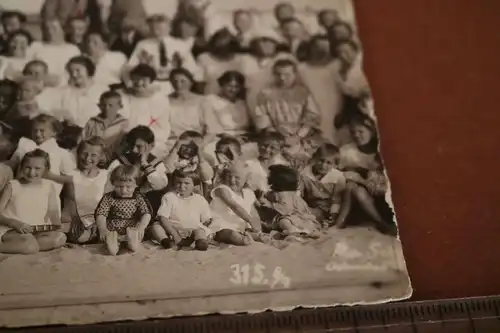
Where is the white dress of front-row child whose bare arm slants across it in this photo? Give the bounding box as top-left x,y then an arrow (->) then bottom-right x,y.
210,184 -> 257,233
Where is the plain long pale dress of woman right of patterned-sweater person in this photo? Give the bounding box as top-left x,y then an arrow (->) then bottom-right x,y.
299,62 -> 342,144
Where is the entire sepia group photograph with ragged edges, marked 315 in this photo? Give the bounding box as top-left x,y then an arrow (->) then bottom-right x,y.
0,0 -> 412,327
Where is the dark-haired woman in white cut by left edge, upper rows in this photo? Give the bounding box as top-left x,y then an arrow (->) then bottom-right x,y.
0,30 -> 33,80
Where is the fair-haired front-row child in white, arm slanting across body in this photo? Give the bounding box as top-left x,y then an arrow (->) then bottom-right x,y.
210,162 -> 262,245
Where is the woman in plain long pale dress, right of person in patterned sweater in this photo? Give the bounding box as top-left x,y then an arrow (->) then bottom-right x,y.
299,35 -> 342,144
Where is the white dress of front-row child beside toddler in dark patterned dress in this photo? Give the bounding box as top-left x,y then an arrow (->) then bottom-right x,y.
158,192 -> 212,236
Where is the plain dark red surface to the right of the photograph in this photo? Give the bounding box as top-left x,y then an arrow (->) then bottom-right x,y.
354,0 -> 500,300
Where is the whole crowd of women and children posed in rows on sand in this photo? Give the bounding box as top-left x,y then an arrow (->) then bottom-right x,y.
0,0 -> 397,255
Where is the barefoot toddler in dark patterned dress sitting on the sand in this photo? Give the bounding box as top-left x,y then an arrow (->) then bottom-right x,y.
95,165 -> 151,256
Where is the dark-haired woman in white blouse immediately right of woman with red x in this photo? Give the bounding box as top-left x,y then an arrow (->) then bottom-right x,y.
168,68 -> 220,148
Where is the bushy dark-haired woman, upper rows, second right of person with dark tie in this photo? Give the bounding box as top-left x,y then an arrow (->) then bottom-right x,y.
198,28 -> 241,95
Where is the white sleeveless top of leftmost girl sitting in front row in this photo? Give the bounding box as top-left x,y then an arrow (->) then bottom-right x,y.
0,179 -> 60,241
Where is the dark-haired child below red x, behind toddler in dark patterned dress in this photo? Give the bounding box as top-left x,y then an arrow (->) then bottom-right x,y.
108,126 -> 168,193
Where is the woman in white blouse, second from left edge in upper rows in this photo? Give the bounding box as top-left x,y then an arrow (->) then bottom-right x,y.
29,20 -> 80,85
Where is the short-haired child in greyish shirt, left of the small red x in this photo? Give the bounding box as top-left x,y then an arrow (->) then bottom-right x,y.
82,91 -> 128,158
